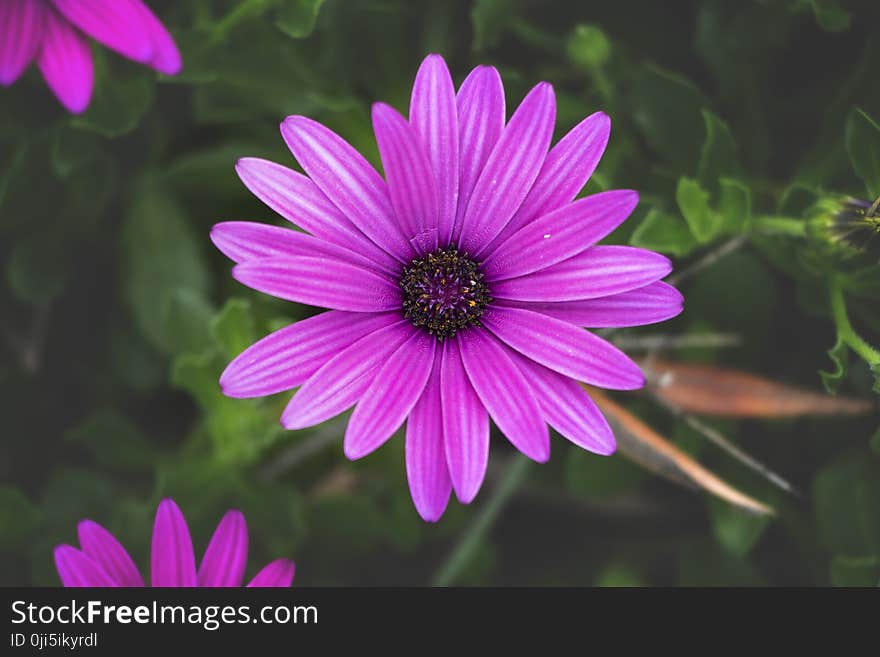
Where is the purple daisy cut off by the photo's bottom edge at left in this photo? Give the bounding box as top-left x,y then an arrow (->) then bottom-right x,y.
55,499 -> 295,587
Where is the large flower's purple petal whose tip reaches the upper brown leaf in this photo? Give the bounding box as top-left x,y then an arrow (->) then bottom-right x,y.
477,306 -> 645,392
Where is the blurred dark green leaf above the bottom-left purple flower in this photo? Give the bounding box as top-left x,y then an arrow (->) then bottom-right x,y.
65,408 -> 158,472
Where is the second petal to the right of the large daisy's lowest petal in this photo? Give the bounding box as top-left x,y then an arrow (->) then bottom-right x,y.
457,328 -> 550,463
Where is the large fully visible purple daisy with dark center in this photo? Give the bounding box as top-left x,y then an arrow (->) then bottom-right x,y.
211,55 -> 682,521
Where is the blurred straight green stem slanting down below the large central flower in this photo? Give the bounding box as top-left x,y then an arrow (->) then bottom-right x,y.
433,454 -> 531,586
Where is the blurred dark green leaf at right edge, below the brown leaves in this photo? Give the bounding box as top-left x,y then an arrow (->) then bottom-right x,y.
813,449 -> 880,556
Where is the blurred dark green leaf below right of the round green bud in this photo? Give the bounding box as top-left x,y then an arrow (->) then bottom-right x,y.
630,66 -> 710,172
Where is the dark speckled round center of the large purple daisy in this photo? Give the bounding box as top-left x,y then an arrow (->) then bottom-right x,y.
400,246 -> 492,340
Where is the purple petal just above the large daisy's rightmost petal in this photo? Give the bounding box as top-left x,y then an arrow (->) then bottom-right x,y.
492,246 -> 672,301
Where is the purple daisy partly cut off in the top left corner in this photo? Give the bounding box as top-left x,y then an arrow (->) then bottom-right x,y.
0,0 -> 181,114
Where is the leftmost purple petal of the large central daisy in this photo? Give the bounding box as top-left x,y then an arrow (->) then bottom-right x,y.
211,221 -> 382,273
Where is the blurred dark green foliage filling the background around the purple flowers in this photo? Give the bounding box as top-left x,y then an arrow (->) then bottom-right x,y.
0,0 -> 880,586
